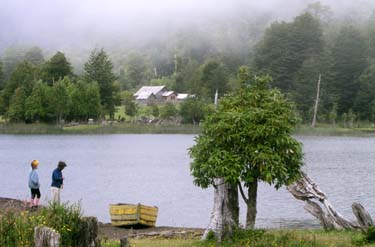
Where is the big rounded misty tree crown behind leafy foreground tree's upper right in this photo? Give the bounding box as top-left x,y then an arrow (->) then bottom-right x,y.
254,13 -> 324,92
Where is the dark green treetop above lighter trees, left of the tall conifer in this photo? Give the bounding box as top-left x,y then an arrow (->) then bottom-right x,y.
42,51 -> 73,85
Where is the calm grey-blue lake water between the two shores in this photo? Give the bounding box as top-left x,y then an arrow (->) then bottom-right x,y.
0,135 -> 375,227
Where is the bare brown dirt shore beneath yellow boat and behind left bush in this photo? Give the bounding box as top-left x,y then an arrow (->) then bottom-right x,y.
0,197 -> 204,239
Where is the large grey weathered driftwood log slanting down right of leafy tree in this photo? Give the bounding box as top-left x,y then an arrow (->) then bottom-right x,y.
287,173 -> 373,230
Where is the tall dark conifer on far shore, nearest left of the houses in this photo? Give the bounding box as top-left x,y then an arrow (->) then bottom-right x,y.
84,49 -> 116,119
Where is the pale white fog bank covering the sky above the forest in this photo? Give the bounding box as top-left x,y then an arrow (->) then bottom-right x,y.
0,0 -> 375,52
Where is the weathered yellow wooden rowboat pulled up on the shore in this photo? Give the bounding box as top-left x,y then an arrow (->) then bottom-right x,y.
109,203 -> 158,227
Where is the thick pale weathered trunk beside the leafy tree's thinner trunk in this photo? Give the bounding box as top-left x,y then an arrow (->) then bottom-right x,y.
202,178 -> 239,242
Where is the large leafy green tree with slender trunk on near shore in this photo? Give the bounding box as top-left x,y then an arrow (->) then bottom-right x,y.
190,68 -> 303,228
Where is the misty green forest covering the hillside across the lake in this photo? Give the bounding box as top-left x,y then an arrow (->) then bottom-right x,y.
0,2 -> 375,127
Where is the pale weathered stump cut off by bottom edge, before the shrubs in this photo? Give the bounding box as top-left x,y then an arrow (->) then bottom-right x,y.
34,226 -> 60,247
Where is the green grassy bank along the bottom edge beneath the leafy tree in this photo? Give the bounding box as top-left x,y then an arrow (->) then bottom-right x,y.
102,230 -> 375,247
